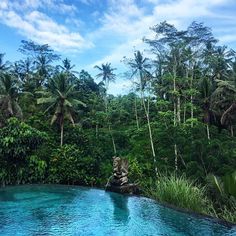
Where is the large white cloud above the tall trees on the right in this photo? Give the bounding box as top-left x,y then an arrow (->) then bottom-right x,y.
89,0 -> 235,67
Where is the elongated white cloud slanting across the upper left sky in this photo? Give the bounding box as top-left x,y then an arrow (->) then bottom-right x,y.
0,0 -> 93,52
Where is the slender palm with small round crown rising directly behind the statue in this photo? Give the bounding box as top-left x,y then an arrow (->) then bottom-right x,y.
94,63 -> 116,155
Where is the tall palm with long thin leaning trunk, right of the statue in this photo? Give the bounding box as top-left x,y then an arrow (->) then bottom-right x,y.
128,51 -> 157,174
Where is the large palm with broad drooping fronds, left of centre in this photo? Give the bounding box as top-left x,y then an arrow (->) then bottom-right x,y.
37,73 -> 86,146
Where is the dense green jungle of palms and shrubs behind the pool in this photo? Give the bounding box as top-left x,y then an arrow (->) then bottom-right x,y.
0,22 -> 236,222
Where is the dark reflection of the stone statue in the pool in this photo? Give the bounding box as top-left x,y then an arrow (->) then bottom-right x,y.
109,193 -> 130,225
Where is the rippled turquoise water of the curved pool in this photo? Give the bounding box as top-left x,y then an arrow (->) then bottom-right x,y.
0,185 -> 236,236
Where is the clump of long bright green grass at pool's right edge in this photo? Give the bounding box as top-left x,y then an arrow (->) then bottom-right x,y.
146,175 -> 212,214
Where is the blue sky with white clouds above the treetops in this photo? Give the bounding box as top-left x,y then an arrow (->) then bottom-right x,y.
0,0 -> 236,94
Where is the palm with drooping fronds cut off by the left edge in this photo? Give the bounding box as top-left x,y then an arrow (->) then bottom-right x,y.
0,73 -> 22,124
